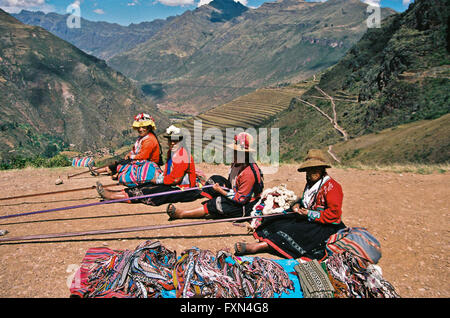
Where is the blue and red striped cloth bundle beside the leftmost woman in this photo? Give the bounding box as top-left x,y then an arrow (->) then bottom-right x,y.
117,160 -> 163,187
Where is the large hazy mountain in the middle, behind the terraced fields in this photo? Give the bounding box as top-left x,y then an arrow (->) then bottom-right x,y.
108,0 -> 394,114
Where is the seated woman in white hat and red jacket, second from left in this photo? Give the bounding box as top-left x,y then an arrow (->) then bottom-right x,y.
97,126 -> 202,206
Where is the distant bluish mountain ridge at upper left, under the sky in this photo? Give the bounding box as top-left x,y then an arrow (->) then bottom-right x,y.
12,10 -> 174,60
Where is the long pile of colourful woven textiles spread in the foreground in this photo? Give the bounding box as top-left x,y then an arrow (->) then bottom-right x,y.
70,241 -> 294,298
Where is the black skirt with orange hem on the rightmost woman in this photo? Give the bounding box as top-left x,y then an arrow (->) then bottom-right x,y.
253,214 -> 345,259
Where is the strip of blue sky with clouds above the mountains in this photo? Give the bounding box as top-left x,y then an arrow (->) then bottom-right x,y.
0,0 -> 414,25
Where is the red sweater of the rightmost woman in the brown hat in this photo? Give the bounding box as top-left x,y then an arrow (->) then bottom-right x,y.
308,178 -> 344,224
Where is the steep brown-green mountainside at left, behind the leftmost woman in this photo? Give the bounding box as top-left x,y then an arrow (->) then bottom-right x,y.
0,10 -> 168,159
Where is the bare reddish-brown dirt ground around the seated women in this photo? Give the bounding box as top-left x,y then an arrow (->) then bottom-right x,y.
0,165 -> 450,298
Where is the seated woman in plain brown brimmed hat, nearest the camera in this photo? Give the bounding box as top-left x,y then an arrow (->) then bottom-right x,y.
235,149 -> 345,259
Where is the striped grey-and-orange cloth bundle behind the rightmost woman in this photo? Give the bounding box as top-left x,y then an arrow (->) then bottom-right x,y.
326,227 -> 381,264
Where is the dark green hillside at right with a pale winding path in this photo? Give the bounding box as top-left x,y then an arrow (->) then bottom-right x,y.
271,0 -> 450,163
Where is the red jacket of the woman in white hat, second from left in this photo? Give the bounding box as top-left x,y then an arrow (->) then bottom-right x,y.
163,147 -> 197,188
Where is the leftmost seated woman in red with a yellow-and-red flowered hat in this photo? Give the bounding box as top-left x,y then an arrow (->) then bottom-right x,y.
89,113 -> 163,180
